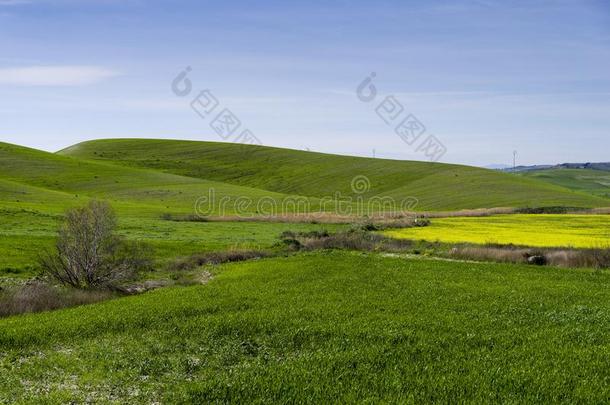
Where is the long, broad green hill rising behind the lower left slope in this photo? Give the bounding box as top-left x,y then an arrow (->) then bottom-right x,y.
59,139 -> 610,210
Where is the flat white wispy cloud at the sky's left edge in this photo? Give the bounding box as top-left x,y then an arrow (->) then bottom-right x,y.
0,66 -> 119,86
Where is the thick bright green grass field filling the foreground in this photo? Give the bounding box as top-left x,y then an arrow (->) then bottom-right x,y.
0,252 -> 610,403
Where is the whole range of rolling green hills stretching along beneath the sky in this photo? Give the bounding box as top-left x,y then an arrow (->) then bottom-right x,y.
0,139 -> 610,216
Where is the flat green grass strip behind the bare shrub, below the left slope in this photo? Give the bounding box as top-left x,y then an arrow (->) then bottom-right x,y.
0,209 -> 348,276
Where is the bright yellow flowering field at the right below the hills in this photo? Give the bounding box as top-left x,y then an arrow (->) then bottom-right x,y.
385,215 -> 610,248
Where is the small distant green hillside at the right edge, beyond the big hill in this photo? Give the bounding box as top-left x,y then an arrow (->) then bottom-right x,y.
522,169 -> 610,198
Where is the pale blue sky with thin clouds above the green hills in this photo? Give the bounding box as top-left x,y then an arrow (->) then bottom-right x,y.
0,0 -> 610,165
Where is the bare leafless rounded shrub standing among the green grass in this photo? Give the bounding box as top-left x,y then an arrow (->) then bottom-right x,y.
40,201 -> 151,288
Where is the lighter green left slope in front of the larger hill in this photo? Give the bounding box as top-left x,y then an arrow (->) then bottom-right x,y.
0,143 -> 314,216
